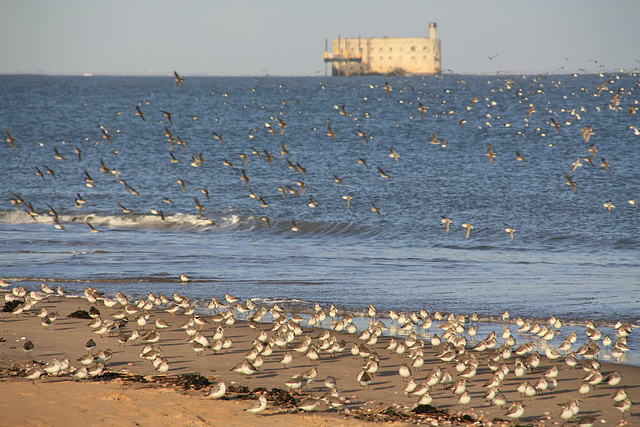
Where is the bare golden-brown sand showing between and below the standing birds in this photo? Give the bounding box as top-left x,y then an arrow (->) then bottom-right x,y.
0,294 -> 640,426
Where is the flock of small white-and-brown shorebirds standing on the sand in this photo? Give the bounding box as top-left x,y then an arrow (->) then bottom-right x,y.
0,280 -> 632,426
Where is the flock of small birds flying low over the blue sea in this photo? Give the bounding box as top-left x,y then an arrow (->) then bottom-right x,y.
5,68 -> 640,239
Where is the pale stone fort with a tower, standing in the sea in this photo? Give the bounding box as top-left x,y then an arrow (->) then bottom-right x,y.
324,22 -> 441,76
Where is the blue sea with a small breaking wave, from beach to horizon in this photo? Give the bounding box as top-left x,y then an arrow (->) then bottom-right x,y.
0,73 -> 640,364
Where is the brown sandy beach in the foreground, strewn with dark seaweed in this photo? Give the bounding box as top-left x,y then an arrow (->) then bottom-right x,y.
0,285 -> 640,426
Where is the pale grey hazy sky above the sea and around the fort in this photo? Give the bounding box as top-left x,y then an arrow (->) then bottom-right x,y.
0,0 -> 640,76
